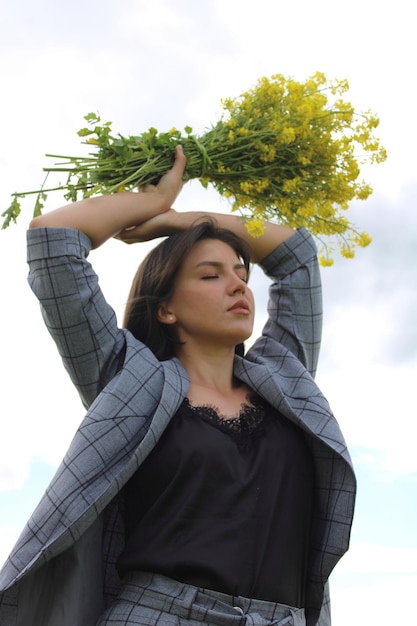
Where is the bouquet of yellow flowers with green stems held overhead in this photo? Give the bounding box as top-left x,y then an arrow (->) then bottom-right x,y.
2,72 -> 386,264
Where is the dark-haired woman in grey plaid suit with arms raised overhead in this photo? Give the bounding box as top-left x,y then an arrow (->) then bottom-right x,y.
0,147 -> 355,626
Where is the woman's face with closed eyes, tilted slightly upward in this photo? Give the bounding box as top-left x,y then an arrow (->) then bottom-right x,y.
159,239 -> 255,348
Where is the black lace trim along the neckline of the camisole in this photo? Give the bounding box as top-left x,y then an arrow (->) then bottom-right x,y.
181,394 -> 266,450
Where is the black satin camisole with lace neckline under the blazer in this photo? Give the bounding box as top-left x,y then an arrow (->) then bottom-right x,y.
118,396 -> 314,607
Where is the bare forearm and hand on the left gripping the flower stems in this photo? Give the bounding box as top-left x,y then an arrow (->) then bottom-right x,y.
30,146 -> 186,248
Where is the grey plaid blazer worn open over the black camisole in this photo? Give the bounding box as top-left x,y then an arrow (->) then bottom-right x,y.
0,228 -> 355,626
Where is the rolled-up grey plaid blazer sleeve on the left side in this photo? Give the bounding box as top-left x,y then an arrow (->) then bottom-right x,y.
27,228 -> 125,408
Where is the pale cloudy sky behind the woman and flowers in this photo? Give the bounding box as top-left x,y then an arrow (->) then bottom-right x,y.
0,0 -> 417,626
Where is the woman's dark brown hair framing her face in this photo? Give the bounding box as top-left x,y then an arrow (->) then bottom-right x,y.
123,219 -> 250,360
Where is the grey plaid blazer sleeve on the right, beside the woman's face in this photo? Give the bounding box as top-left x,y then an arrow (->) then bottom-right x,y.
254,228 -> 323,376
